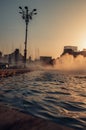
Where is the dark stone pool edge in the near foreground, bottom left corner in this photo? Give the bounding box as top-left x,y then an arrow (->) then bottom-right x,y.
0,103 -> 73,130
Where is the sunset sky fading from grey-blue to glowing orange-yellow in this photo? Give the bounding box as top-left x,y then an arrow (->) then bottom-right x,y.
0,0 -> 86,58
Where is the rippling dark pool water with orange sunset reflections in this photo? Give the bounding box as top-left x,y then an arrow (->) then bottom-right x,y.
0,70 -> 86,130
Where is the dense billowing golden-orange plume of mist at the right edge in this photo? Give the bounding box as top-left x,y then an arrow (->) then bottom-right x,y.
54,54 -> 86,71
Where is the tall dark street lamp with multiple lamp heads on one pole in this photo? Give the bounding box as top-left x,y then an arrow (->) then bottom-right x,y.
19,6 -> 37,66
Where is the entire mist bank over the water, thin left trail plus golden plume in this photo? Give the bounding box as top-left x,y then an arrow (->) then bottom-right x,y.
27,54 -> 86,72
